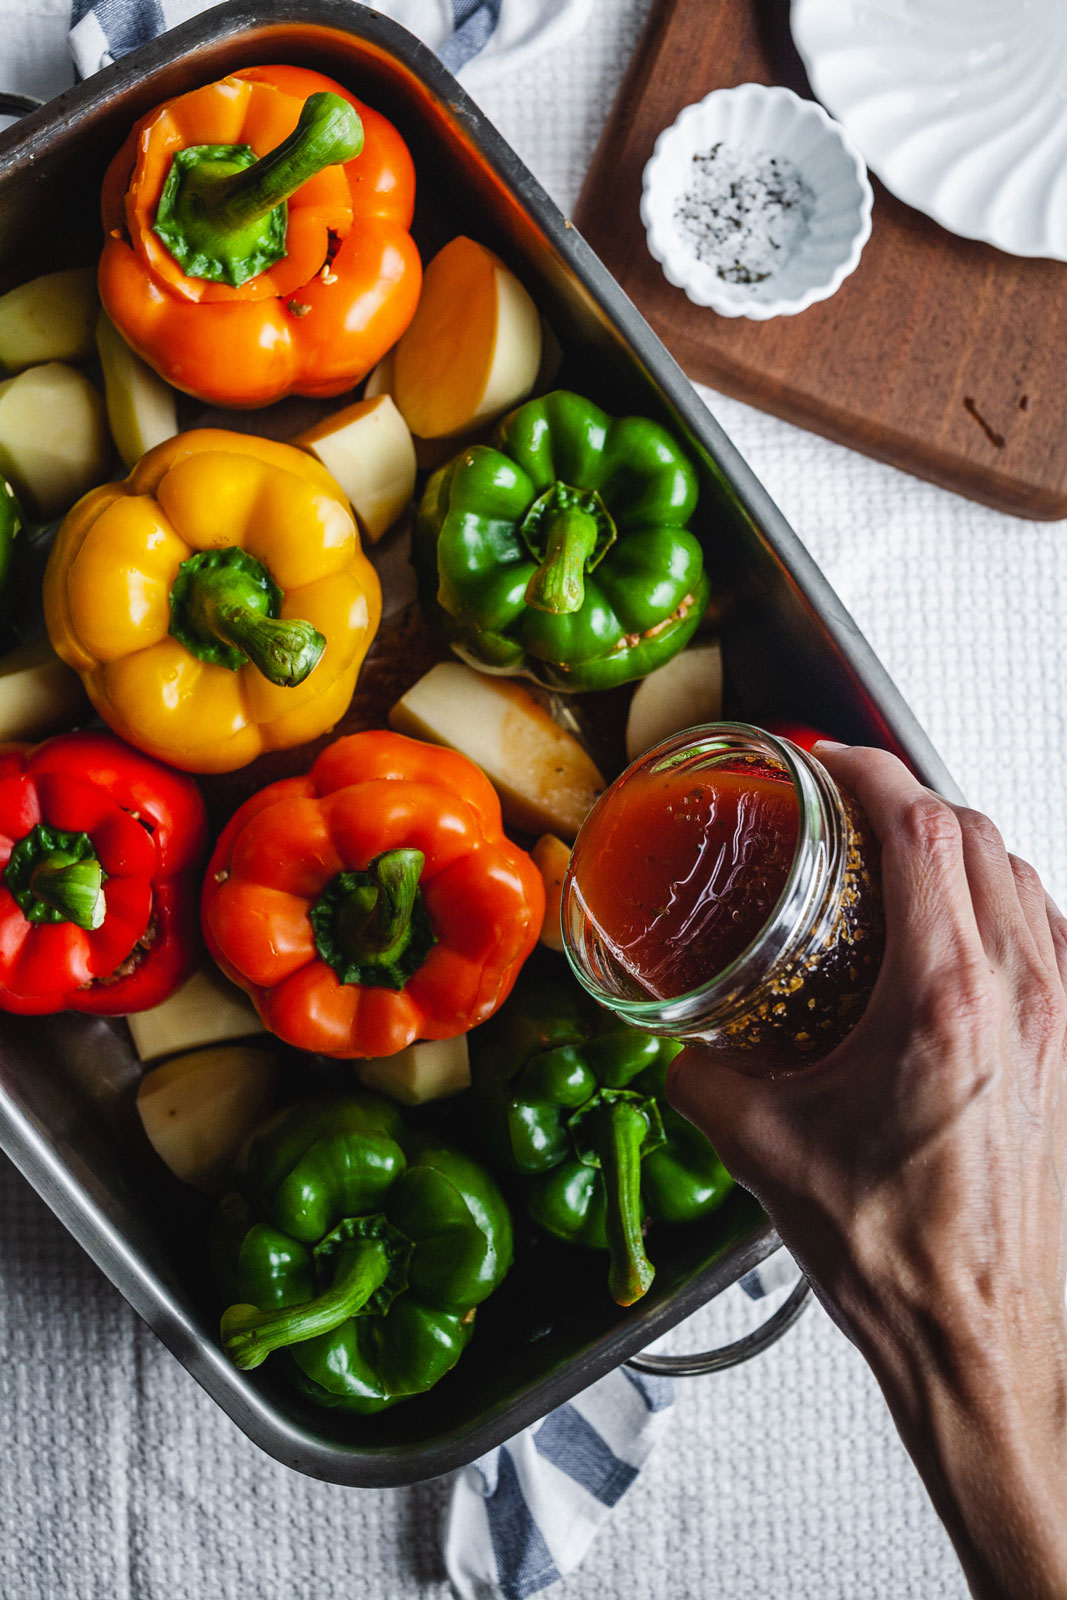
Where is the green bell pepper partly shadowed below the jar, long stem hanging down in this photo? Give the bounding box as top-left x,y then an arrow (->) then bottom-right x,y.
470,968 -> 733,1306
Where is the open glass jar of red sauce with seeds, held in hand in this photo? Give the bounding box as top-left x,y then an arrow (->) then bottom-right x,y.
561,723 -> 883,1075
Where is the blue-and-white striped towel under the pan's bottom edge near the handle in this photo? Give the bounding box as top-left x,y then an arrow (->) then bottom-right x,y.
445,1250 -> 797,1600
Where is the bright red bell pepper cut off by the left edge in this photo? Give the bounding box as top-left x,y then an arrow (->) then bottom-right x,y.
0,733 -> 206,1016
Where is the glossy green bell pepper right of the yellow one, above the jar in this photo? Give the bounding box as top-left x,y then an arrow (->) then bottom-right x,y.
413,389 -> 709,690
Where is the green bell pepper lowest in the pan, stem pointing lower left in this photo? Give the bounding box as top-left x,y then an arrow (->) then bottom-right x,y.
213,1094 -> 512,1414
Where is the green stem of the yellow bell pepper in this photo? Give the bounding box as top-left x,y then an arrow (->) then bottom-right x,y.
186,566 -> 326,688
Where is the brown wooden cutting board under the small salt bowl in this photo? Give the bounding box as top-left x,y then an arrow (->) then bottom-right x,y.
574,0 -> 1067,518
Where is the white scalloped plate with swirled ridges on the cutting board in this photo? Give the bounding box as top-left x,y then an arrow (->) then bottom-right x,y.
790,0 -> 1067,261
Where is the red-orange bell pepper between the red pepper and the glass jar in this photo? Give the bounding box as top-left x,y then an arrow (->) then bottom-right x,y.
202,731 -> 544,1058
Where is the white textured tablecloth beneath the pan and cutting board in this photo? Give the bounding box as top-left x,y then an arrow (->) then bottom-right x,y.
0,0 -> 1067,1600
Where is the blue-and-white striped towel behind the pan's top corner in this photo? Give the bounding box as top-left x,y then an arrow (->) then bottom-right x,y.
70,0 -> 590,82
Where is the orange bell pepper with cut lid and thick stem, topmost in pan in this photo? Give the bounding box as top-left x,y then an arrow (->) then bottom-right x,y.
99,67 -> 422,406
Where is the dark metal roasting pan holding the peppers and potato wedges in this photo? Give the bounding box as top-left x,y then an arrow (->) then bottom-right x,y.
0,0 -> 957,1486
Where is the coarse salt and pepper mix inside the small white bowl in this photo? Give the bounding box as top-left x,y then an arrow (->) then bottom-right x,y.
673,141 -> 816,283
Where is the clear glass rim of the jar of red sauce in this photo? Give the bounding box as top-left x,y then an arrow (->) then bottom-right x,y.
560,722 -> 832,1034
